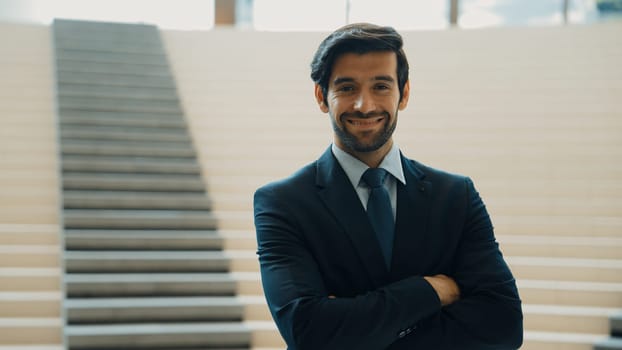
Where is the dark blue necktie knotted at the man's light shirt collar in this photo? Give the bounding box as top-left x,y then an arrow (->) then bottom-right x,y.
363,168 -> 395,269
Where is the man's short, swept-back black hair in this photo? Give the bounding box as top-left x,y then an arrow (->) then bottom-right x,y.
311,23 -> 408,101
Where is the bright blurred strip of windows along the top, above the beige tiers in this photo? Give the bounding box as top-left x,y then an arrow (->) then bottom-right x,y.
0,0 -> 620,31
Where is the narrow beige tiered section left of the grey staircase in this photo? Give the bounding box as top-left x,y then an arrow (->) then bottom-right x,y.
0,23 -> 62,349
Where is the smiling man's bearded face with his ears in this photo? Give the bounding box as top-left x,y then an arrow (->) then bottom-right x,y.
315,52 -> 409,155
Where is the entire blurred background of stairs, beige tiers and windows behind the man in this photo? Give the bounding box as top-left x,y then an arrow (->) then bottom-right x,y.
0,0 -> 622,350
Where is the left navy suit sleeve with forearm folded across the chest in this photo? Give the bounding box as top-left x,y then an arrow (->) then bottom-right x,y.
254,187 -> 440,350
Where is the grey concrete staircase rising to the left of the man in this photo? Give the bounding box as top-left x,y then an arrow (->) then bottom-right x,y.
53,20 -> 251,349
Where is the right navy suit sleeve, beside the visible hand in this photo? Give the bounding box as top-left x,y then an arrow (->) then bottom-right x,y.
390,178 -> 523,350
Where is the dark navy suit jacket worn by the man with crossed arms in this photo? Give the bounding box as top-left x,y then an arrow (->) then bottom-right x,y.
254,148 -> 523,350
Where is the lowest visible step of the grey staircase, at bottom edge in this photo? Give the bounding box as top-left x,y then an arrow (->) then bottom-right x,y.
65,323 -> 251,349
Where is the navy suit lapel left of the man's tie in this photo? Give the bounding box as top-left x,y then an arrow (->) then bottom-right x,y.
316,148 -> 389,285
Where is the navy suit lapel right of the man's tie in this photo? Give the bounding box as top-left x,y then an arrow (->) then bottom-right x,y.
391,156 -> 433,279
